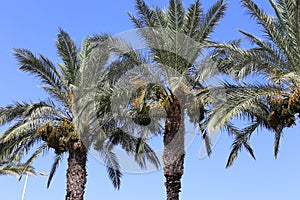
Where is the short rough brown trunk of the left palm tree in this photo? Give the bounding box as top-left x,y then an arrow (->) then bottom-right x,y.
66,140 -> 87,200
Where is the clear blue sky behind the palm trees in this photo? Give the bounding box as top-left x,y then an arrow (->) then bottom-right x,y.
0,0 -> 300,200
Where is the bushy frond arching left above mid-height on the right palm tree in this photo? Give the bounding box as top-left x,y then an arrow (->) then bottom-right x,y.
214,41 -> 292,80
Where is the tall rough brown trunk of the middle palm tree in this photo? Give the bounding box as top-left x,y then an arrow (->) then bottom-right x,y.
163,96 -> 185,200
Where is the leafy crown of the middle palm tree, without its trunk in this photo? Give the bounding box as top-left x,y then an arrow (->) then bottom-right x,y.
104,0 -> 227,128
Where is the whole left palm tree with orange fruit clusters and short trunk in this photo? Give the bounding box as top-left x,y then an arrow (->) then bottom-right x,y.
0,29 -> 156,200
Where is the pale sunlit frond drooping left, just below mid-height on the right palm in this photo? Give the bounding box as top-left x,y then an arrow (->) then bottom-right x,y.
208,83 -> 282,132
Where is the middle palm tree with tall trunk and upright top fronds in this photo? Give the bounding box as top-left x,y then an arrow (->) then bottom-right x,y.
108,0 -> 227,200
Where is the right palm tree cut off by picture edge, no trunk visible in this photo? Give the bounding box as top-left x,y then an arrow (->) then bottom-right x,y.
211,0 -> 300,166
